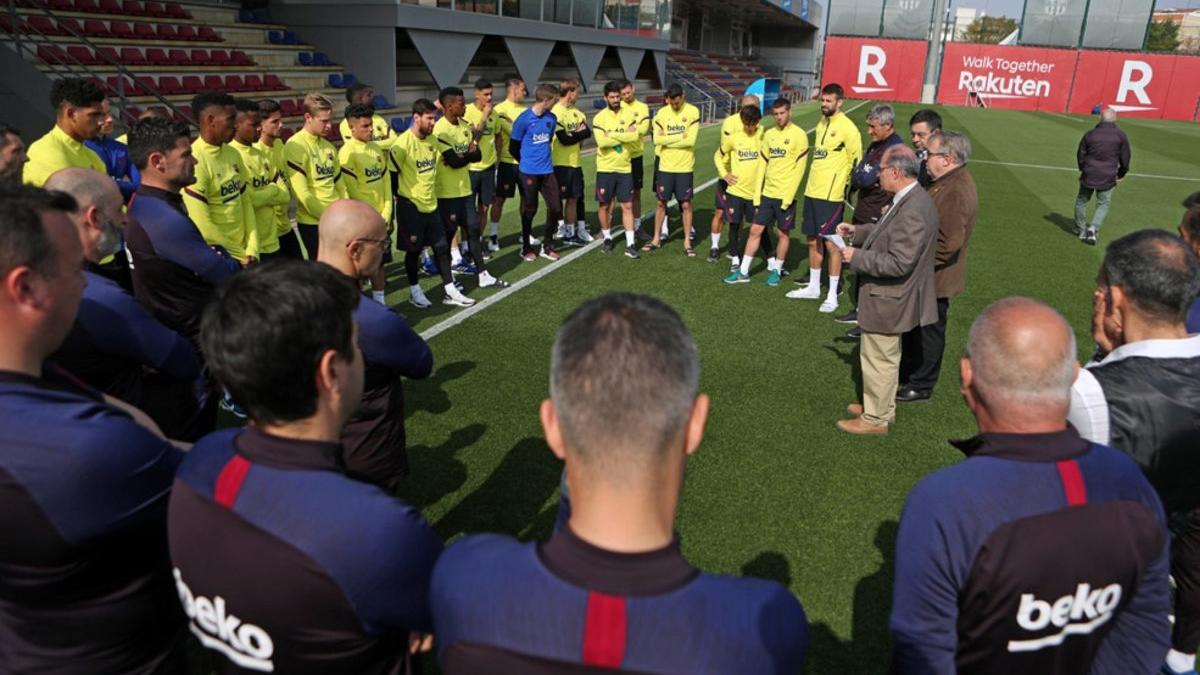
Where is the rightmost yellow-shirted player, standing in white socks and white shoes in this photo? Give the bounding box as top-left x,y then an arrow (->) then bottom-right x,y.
787,84 -> 863,312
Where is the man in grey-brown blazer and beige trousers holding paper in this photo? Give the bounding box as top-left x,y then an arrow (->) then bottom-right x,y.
838,145 -> 938,434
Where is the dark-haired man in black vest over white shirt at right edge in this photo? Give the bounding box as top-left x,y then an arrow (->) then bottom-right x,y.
1068,229 -> 1200,675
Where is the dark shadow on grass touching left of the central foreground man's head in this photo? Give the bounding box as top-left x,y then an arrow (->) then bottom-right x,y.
434,437 -> 562,538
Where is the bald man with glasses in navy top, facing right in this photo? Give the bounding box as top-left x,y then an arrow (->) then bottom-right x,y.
317,199 -> 433,491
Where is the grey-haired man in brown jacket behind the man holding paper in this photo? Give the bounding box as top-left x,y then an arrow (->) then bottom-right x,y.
896,131 -> 979,404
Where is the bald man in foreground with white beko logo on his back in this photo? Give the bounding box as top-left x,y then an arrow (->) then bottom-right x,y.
890,298 -> 1170,675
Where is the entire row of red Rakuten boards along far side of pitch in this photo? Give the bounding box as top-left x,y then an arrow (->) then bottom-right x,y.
821,37 -> 1200,120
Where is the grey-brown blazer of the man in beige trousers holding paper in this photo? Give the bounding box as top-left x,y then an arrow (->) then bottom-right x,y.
850,185 -> 937,334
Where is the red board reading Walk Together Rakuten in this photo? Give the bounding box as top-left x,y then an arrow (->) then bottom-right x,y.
937,42 -> 1079,113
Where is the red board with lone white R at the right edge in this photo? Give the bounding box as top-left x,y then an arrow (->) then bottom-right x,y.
1068,52 -> 1200,120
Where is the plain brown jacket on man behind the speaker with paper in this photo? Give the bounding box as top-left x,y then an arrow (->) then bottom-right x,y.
929,166 -> 979,298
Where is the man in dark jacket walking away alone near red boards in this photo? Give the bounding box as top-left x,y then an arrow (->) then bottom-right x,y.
1075,108 -> 1129,246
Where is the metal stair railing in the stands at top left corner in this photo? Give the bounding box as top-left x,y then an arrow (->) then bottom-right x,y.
0,0 -> 196,127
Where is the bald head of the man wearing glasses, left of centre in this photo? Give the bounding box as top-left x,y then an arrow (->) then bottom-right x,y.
317,199 -> 388,280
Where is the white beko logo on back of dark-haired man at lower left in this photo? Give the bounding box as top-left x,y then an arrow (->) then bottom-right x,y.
173,568 -> 275,673
